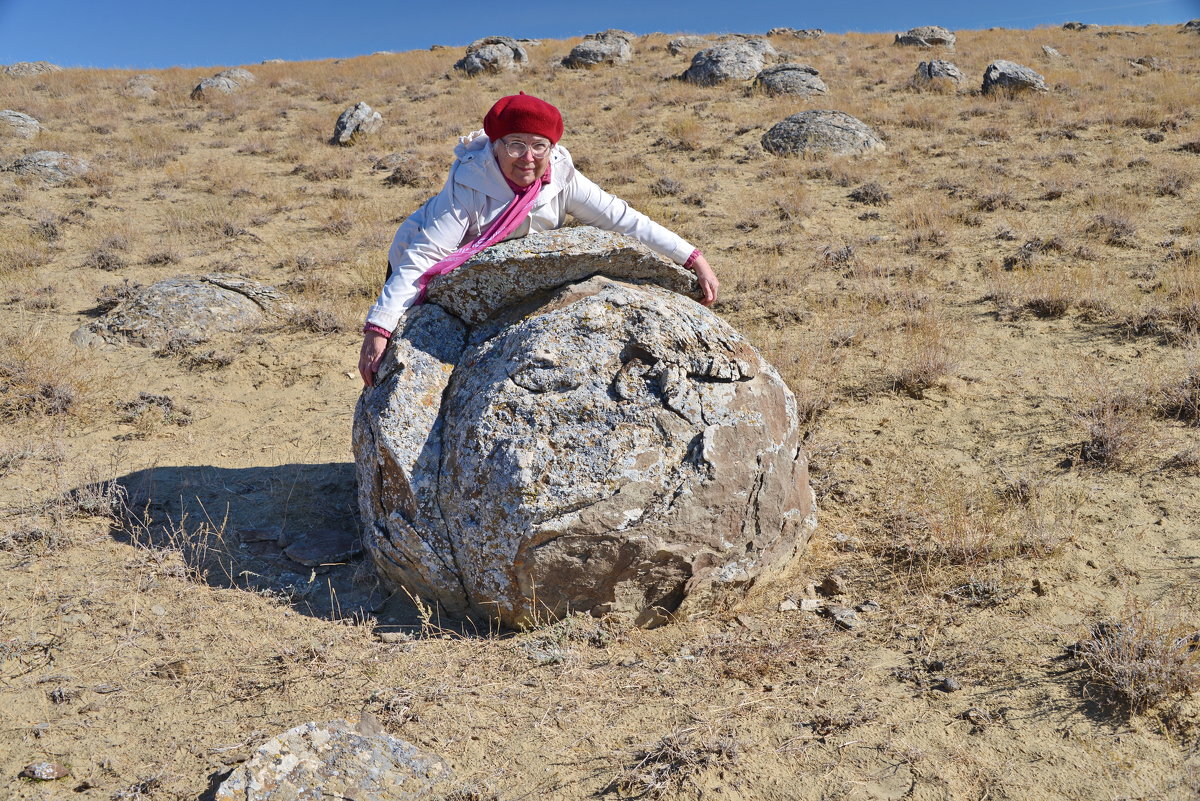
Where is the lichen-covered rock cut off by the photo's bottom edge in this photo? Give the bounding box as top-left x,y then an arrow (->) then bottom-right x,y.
215,718 -> 455,801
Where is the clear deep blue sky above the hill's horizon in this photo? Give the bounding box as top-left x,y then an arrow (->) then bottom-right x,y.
0,0 -> 1200,68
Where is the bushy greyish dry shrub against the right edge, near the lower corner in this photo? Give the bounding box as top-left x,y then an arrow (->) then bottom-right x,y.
1069,606 -> 1200,712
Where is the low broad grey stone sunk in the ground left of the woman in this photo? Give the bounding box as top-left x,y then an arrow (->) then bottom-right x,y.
71,273 -> 288,348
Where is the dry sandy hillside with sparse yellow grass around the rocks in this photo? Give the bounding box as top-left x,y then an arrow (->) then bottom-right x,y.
0,21 -> 1200,801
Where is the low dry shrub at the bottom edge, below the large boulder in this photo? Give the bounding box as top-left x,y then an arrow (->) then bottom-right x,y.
606,727 -> 739,799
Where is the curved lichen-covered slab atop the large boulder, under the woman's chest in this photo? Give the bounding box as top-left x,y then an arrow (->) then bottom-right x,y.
428,225 -> 703,325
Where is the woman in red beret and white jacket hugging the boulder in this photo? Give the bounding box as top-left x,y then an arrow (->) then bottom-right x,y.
359,92 -> 719,386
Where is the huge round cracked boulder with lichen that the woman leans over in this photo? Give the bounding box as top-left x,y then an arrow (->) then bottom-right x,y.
354,228 -> 815,627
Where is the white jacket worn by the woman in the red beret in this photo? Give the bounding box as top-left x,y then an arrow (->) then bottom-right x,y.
367,131 -> 695,331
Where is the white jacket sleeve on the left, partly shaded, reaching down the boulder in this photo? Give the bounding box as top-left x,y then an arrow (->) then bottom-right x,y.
367,174 -> 478,331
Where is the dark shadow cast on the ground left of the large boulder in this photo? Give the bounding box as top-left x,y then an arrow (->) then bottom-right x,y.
102,462 -> 441,636
